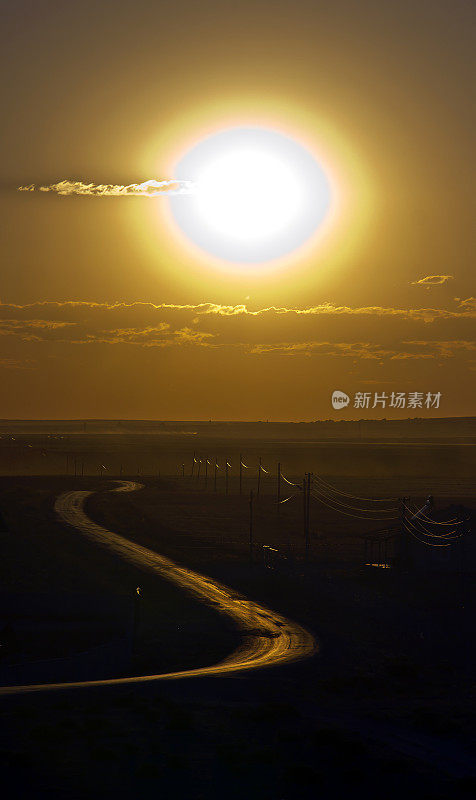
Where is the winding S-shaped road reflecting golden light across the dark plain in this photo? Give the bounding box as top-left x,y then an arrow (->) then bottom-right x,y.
0,481 -> 317,695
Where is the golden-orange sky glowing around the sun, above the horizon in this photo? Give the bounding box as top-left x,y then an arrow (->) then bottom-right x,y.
0,0 -> 476,420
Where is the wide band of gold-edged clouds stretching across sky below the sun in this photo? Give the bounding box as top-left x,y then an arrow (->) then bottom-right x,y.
0,298 -> 476,362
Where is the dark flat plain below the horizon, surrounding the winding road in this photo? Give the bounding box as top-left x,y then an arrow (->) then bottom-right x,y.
0,419 -> 476,798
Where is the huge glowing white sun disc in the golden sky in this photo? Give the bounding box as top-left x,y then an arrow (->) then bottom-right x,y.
169,127 -> 332,265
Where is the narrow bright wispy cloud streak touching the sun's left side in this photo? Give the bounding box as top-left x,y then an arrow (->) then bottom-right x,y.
18,179 -> 195,197
